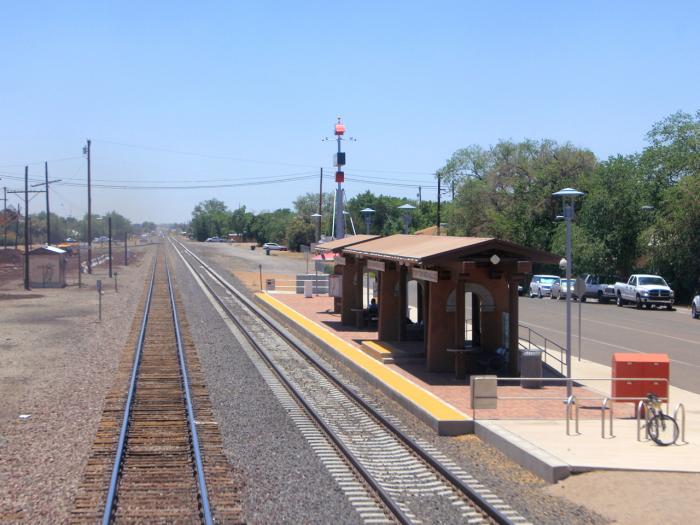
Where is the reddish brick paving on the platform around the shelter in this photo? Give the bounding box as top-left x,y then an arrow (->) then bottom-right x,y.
266,294 -> 634,420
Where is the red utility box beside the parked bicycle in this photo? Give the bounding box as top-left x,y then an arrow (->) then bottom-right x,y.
612,353 -> 671,402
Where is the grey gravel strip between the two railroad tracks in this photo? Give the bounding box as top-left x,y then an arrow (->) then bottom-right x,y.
173,246 -> 360,524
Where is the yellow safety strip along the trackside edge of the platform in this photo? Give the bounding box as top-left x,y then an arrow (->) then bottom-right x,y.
255,292 -> 471,421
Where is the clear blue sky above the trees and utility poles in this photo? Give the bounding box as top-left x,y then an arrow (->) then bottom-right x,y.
0,1 -> 700,222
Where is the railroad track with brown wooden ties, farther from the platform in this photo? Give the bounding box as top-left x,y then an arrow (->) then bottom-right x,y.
71,250 -> 240,524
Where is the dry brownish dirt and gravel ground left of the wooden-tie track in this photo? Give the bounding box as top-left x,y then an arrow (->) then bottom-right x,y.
0,247 -> 154,523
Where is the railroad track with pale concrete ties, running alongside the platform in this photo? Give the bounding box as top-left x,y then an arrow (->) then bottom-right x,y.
171,239 -> 527,524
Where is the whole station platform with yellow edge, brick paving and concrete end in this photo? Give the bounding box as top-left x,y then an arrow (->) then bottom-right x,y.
258,293 -> 700,483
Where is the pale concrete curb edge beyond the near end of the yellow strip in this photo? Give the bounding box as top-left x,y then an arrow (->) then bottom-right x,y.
473,420 -> 574,483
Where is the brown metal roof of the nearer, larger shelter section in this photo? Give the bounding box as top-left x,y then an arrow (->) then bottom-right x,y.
343,235 -> 559,264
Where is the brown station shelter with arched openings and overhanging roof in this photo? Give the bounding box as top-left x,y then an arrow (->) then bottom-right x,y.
326,235 -> 560,375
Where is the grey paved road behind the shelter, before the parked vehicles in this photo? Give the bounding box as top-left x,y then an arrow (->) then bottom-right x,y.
520,297 -> 700,393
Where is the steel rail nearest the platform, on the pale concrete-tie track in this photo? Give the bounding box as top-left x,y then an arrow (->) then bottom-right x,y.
170,238 -> 515,525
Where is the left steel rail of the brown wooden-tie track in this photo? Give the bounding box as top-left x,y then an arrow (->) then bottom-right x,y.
102,257 -> 158,525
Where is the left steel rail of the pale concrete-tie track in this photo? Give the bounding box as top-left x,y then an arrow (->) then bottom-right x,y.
170,238 -> 412,525
